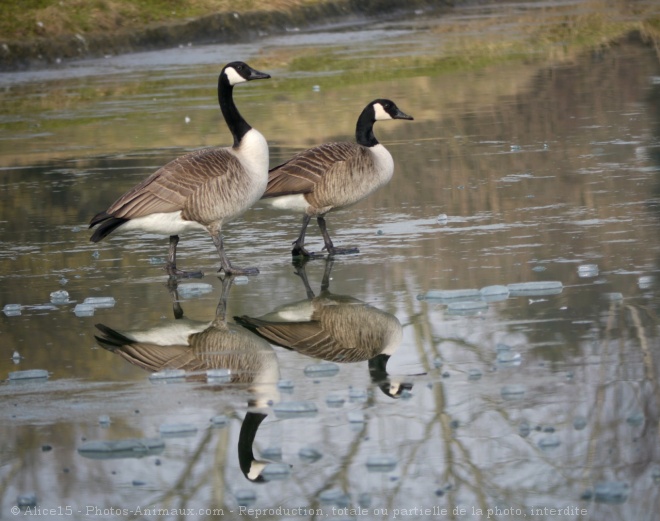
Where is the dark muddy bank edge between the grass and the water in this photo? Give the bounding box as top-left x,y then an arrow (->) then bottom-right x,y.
0,0 -> 455,71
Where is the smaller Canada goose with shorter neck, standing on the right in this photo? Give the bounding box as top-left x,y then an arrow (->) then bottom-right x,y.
262,99 -> 413,257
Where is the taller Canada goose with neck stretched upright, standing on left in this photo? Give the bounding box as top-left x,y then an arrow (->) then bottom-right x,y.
89,62 -> 270,277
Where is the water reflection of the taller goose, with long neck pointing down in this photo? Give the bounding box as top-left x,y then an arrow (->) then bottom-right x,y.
95,277 -> 280,482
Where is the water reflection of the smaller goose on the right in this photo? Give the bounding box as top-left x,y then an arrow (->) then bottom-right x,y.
234,259 -> 412,398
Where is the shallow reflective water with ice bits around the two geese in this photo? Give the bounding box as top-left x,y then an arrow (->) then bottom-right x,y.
0,1 -> 660,520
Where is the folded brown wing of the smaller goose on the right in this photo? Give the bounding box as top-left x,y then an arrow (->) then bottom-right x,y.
262,143 -> 361,198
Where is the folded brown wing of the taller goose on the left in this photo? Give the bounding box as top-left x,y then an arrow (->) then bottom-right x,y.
107,148 -> 241,219
